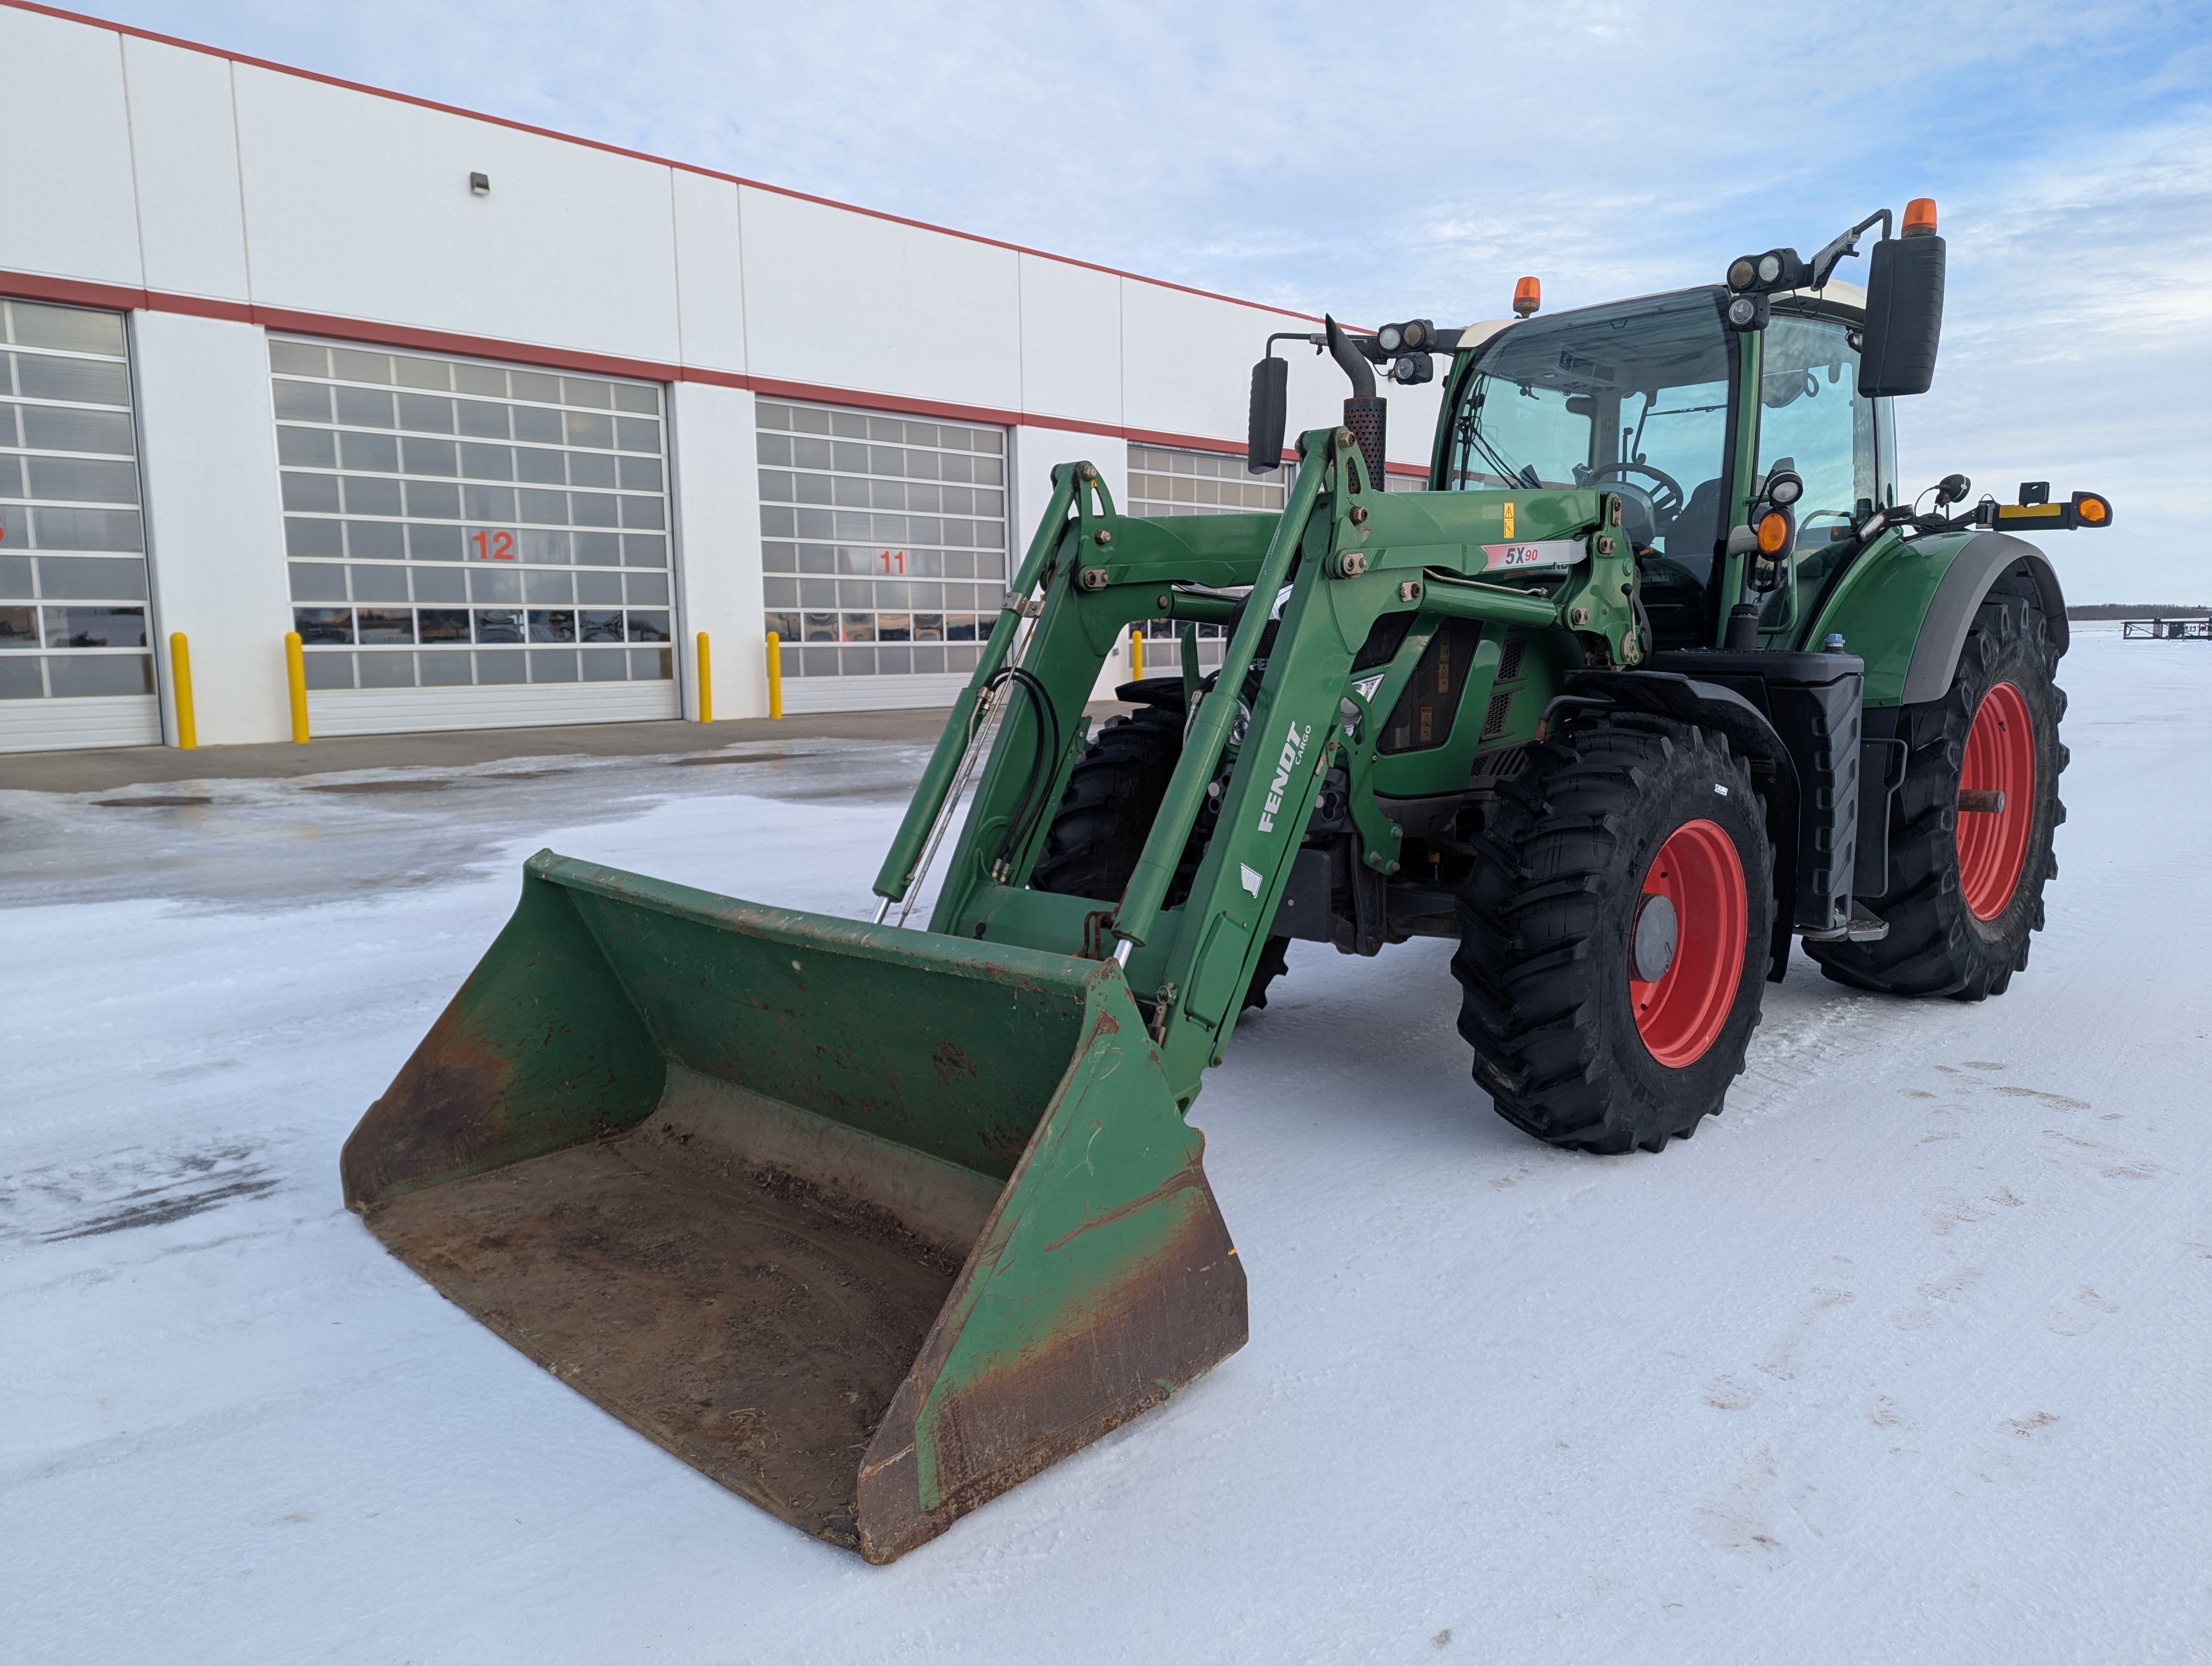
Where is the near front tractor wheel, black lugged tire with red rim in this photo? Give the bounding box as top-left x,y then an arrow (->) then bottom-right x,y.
1451,713 -> 1774,1155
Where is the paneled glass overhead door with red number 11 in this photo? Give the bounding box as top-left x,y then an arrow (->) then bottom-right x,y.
756,398 -> 1006,713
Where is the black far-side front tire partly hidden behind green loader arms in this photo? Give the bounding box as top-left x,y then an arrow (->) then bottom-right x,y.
1028,706 -> 1290,1011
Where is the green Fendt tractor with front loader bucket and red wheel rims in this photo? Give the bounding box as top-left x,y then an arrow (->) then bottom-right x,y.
343,201 -> 2112,1562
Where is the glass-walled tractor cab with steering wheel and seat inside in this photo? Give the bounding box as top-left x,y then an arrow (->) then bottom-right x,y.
1431,283 -> 1896,650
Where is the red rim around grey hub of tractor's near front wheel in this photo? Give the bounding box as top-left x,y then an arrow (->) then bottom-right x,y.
1628,821 -> 1752,1071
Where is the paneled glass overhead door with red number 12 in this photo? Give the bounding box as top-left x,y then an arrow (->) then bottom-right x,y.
270,336 -> 679,734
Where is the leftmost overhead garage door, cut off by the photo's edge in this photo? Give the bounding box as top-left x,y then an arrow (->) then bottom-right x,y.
0,301 -> 162,752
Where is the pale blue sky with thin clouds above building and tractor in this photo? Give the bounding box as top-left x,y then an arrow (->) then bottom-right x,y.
102,0 -> 2212,602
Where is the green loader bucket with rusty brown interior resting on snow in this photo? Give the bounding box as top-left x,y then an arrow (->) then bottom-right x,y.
343,852 -> 1245,1562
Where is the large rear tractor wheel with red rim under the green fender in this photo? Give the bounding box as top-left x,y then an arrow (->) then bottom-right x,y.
1805,580 -> 2066,1000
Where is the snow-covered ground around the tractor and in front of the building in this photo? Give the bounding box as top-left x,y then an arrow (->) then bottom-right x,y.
0,631 -> 2212,1666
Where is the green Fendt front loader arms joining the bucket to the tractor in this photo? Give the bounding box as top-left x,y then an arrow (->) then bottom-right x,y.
878,429 -> 1637,1111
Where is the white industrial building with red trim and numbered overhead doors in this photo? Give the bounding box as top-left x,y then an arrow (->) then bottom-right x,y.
0,0 -> 1473,750
